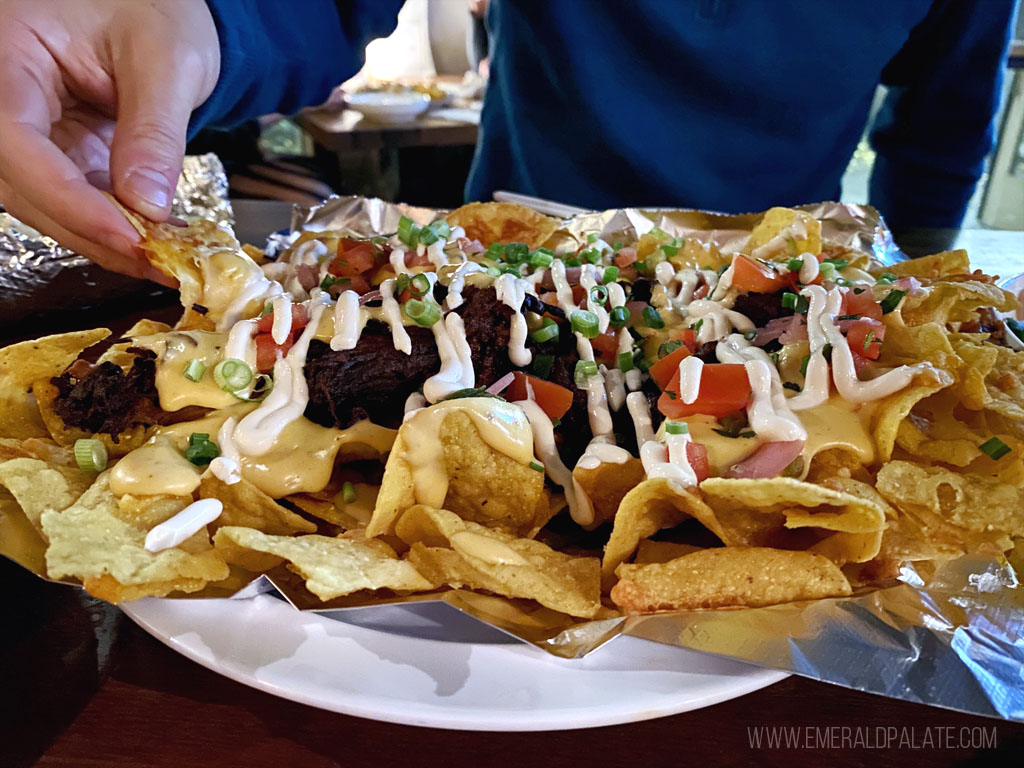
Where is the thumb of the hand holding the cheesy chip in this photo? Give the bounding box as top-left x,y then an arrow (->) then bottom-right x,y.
111,45 -> 196,221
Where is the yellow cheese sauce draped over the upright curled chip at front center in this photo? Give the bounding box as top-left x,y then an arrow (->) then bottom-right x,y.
402,397 -> 534,508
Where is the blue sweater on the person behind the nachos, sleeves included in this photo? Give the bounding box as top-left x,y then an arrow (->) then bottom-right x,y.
193,0 -> 1015,226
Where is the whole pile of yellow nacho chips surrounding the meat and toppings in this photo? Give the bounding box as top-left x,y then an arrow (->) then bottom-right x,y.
0,198 -> 1024,620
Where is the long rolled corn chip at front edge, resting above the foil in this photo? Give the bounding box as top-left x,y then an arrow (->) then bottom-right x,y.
611,547 -> 851,614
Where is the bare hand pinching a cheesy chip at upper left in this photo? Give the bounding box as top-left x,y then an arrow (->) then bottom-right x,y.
0,0 -> 220,285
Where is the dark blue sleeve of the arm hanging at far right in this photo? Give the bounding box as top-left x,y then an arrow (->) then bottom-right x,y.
870,0 -> 1016,227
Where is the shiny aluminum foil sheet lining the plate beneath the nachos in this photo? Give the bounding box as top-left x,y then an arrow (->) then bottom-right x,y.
0,198 -> 1024,721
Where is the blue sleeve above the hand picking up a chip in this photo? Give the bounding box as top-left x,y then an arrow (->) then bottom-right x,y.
188,0 -> 402,137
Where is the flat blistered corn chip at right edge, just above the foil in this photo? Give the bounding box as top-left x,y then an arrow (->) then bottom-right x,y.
876,461 -> 1024,547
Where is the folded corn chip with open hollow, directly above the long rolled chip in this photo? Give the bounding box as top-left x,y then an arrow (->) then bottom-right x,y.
700,477 -> 886,564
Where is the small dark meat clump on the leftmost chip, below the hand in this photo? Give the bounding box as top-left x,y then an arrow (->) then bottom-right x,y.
51,357 -> 158,435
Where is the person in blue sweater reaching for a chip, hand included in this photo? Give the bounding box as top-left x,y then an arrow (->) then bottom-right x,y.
0,0 -> 1016,278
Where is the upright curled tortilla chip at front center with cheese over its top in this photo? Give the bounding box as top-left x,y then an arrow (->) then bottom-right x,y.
367,398 -> 552,537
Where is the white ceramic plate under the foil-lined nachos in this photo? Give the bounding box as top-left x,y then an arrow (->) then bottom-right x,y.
123,594 -> 786,731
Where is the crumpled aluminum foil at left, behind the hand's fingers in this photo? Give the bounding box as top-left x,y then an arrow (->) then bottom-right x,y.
0,154 -> 233,323
